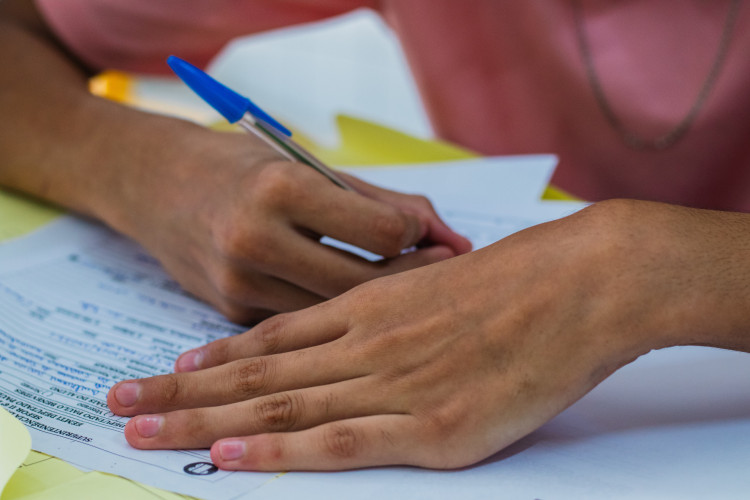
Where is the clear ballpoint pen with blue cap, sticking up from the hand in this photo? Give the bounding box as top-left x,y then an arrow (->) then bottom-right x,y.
167,56 -> 354,191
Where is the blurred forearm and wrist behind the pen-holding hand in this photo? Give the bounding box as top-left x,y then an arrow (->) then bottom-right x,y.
0,2 -> 207,232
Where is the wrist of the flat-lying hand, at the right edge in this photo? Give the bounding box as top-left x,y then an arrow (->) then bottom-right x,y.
584,200 -> 750,356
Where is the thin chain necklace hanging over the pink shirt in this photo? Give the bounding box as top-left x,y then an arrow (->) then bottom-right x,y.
572,0 -> 741,151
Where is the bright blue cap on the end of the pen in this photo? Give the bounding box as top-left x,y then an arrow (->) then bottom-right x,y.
167,56 -> 292,136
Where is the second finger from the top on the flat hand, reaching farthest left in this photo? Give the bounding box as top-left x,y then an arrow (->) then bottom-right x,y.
107,342 -> 366,416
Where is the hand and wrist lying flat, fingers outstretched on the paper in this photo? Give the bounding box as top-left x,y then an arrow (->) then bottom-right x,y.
107,200 -> 750,471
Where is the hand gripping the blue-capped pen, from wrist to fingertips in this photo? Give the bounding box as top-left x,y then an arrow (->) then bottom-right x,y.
103,130 -> 471,323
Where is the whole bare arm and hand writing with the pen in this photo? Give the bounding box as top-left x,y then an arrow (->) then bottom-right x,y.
0,0 -> 471,323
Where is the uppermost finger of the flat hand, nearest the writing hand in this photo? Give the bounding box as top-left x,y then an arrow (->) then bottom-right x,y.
175,302 -> 348,372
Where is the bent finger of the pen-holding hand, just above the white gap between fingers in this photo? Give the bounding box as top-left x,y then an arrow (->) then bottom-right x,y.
284,172 -> 428,257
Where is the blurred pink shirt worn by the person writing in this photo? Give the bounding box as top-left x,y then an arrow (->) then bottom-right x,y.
37,0 -> 750,211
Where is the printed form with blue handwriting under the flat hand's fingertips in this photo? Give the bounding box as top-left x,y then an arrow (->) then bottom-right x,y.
0,217 -> 273,498
